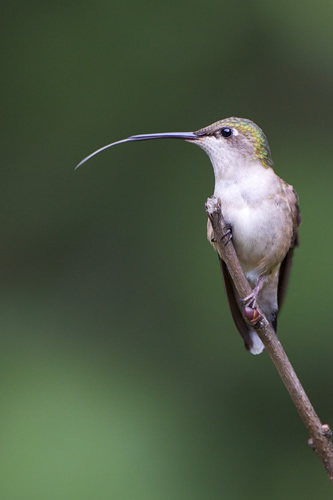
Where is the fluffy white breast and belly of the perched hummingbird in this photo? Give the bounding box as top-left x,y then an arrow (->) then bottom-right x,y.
210,165 -> 290,281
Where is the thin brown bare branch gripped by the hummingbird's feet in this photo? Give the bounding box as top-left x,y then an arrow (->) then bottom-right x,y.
206,196 -> 333,482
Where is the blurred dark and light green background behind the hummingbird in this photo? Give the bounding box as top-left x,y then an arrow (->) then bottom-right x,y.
0,0 -> 333,500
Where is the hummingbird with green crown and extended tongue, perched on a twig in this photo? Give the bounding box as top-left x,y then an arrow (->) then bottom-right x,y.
76,117 -> 301,354
